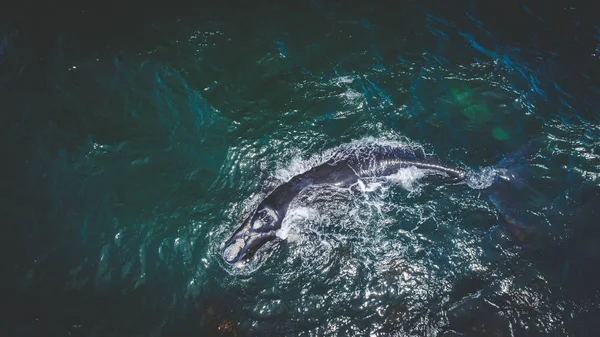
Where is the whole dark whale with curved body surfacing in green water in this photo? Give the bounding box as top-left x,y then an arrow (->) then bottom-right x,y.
221,145 -> 466,265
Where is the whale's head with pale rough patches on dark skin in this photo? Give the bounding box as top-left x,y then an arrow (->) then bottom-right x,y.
221,204 -> 282,264
